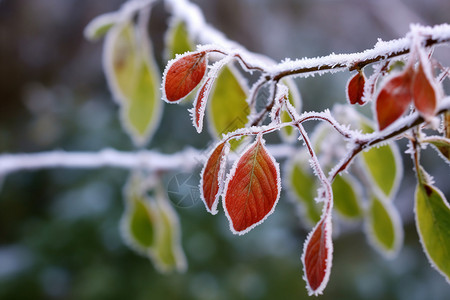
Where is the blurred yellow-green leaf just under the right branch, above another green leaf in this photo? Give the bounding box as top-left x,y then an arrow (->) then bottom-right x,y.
360,142 -> 403,198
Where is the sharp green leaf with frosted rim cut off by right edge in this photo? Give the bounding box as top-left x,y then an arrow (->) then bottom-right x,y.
415,183 -> 450,283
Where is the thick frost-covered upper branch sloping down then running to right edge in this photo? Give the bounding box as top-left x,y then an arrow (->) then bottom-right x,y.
165,0 -> 450,82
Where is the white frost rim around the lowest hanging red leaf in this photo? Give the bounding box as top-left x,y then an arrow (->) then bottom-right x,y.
301,212 -> 333,296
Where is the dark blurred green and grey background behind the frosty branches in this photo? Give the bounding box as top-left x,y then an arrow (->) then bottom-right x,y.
0,0 -> 450,300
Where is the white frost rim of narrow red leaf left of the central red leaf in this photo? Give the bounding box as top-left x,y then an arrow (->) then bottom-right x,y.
199,141 -> 230,215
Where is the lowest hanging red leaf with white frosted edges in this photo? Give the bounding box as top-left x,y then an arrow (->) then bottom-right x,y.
302,215 -> 333,296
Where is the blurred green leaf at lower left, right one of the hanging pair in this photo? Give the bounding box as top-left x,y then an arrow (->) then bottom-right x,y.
153,195 -> 187,273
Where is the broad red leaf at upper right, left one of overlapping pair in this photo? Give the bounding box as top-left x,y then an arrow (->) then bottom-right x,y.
376,68 -> 413,130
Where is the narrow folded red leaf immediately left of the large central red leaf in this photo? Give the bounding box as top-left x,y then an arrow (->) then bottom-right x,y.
200,142 -> 230,215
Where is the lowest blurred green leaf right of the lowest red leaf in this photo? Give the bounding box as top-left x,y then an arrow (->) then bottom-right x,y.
366,196 -> 403,258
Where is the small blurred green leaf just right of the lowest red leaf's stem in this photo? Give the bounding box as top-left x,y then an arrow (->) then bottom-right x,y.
331,174 -> 362,219
